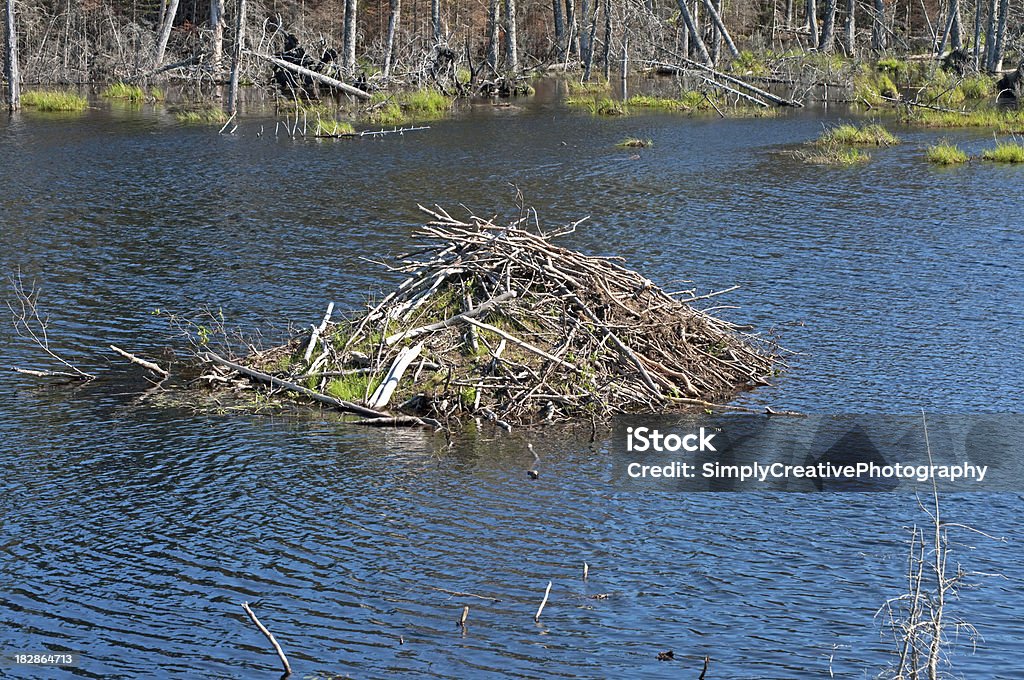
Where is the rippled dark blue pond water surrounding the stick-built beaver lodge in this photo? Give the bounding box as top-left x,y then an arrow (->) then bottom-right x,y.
0,87 -> 1024,679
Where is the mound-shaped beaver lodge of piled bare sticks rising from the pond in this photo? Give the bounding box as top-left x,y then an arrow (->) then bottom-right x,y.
197,206 -> 780,429
